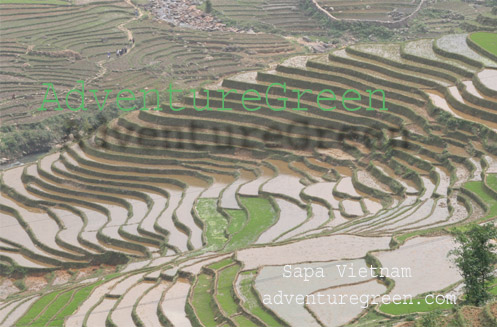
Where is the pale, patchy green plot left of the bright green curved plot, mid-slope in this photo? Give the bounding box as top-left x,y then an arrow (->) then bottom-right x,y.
196,199 -> 228,250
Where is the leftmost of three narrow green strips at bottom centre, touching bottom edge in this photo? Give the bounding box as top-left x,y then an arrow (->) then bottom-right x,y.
192,274 -> 218,326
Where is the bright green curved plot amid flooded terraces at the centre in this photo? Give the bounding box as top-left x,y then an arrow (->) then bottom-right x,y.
226,197 -> 277,250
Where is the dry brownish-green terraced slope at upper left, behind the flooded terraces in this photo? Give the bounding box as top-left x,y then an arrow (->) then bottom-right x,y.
0,0 -> 303,162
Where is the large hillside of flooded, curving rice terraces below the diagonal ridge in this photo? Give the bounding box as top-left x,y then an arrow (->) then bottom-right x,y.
0,25 -> 497,326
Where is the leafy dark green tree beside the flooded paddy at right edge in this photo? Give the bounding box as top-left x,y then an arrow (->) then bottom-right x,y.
449,224 -> 497,306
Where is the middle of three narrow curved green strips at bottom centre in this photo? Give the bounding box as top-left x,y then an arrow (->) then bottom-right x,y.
216,265 -> 240,317
